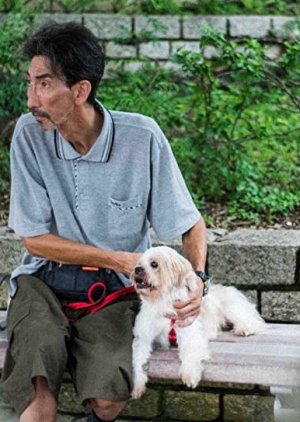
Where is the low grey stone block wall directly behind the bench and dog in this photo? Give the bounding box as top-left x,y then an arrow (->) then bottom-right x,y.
0,227 -> 300,323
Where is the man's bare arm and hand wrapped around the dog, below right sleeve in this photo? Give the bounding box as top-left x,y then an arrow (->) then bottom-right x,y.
170,219 -> 207,327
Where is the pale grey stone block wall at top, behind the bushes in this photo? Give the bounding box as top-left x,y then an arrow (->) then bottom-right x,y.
19,13 -> 299,76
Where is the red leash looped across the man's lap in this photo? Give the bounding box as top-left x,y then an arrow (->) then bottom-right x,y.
63,281 -> 135,322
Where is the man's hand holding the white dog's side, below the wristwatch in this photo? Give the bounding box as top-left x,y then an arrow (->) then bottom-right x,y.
165,280 -> 203,327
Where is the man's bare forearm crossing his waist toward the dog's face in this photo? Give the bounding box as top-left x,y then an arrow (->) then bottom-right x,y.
23,234 -> 140,275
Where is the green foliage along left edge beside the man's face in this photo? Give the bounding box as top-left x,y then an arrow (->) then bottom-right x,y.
0,0 -> 41,198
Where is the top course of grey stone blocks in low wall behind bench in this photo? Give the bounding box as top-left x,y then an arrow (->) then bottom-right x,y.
0,227 -> 300,286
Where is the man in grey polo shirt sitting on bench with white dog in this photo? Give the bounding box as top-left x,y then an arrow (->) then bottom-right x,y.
2,23 -> 206,422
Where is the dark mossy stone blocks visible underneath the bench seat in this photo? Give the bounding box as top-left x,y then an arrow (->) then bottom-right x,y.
53,382 -> 274,422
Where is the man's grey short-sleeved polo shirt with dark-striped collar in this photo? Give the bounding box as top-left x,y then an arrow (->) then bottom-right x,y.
9,103 -> 201,295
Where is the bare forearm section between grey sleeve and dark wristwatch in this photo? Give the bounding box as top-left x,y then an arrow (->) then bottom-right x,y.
182,218 -> 207,271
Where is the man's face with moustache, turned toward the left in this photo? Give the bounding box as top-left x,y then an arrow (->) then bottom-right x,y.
27,56 -> 74,130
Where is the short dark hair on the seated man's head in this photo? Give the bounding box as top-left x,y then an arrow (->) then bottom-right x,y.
23,22 -> 104,104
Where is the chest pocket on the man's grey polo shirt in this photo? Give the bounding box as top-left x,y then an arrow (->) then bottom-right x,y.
108,196 -> 146,247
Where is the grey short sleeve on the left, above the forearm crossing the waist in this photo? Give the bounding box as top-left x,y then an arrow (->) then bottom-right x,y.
8,124 -> 52,237
